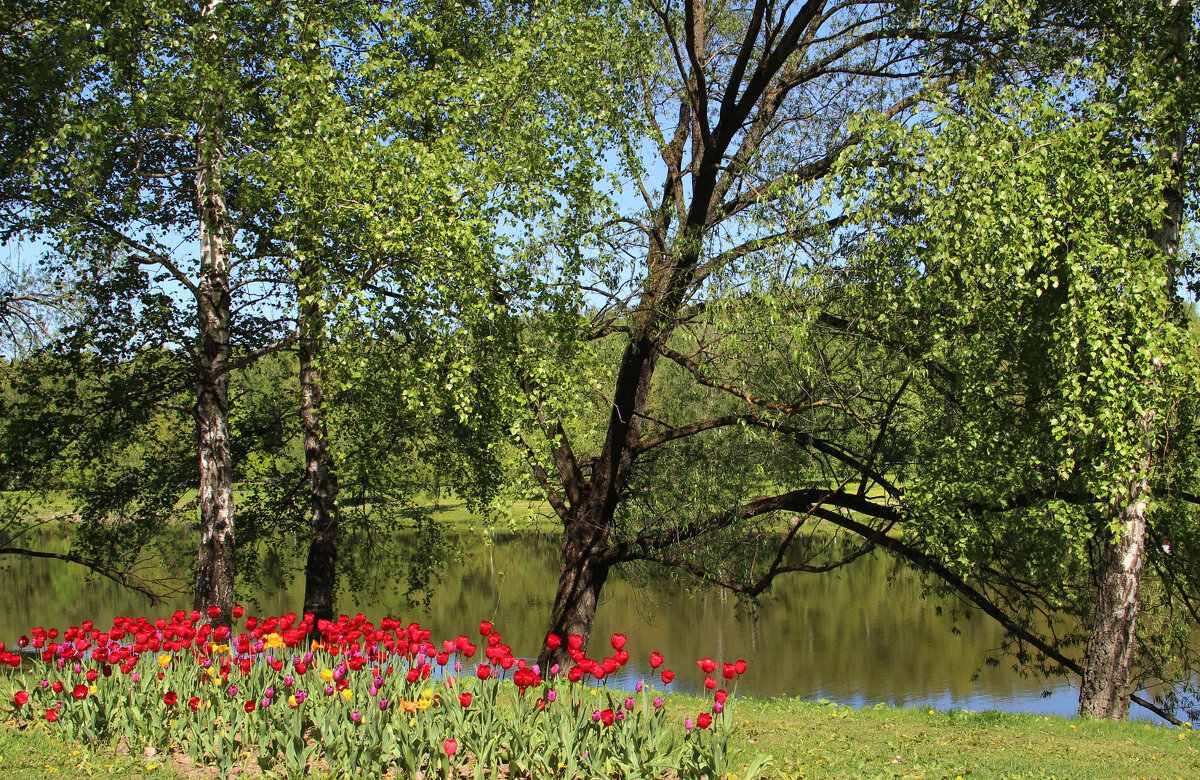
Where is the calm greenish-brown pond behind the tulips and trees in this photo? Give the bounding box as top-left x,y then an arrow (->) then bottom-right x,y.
0,523 -> 1148,716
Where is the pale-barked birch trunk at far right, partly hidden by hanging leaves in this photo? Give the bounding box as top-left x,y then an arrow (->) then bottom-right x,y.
1079,0 -> 1194,720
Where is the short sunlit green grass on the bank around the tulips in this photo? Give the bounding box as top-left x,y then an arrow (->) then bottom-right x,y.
0,696 -> 1200,780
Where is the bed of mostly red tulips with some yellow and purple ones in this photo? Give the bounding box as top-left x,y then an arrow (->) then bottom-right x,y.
0,608 -> 766,779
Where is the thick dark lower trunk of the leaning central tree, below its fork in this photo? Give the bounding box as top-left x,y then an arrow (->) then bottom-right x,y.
538,516 -> 608,674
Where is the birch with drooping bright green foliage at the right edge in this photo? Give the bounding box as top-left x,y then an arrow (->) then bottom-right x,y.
844,6 -> 1196,718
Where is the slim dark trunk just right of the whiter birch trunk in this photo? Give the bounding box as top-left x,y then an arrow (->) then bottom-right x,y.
299,263 -> 340,620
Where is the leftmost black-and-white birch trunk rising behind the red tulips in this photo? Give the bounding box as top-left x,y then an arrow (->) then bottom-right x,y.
193,134 -> 234,625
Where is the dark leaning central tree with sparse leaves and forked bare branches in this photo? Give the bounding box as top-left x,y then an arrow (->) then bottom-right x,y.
477,0 -> 1041,667
